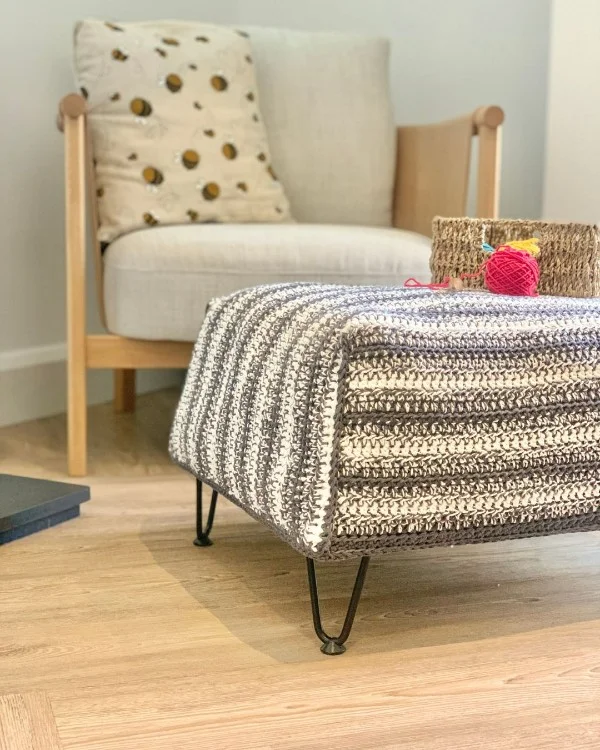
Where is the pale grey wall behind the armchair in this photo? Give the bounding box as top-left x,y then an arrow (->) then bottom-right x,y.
0,0 -> 550,423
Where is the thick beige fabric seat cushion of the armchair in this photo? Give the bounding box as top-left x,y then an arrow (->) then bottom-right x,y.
104,224 -> 431,341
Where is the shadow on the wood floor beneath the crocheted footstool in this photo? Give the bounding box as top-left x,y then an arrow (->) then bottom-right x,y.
142,498 -> 600,662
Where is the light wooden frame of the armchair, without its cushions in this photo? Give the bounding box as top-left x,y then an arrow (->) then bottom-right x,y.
58,94 -> 504,476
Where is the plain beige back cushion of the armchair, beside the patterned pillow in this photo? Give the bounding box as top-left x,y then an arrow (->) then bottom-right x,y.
245,27 -> 396,226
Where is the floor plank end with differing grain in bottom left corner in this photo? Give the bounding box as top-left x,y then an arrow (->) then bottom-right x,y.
0,692 -> 63,750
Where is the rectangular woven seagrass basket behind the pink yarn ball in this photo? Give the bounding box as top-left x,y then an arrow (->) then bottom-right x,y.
431,216 -> 600,297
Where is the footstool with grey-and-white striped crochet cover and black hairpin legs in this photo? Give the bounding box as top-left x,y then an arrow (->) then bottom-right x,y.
170,283 -> 600,654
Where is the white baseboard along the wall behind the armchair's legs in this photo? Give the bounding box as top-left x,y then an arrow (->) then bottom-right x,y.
0,343 -> 181,427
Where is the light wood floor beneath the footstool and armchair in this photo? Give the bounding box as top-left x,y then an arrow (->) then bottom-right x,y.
0,392 -> 600,750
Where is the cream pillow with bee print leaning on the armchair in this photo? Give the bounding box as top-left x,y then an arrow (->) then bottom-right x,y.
75,21 -> 291,242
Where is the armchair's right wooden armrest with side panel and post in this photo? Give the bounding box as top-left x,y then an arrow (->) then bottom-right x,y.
393,106 -> 504,236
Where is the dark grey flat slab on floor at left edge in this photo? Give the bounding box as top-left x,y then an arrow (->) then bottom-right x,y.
0,474 -> 90,544
